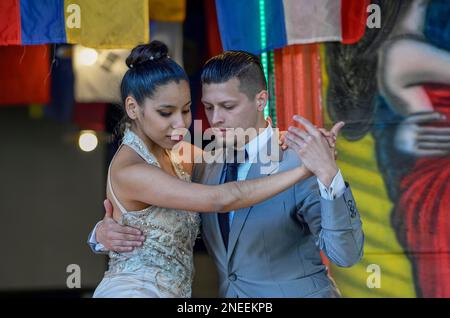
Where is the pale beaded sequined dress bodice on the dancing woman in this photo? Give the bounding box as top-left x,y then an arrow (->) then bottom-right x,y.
105,130 -> 200,297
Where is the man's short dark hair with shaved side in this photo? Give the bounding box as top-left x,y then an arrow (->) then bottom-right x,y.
201,51 -> 267,100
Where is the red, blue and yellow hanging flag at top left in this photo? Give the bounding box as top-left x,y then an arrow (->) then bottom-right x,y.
0,0 -> 149,48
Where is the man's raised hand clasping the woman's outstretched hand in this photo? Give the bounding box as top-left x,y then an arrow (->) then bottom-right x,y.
285,115 -> 343,187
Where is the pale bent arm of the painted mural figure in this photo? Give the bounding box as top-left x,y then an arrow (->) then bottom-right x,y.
378,0 -> 450,116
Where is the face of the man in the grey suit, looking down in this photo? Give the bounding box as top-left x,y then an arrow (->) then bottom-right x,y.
202,77 -> 260,144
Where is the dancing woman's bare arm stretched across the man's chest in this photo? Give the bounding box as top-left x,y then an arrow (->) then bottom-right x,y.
112,163 -> 311,212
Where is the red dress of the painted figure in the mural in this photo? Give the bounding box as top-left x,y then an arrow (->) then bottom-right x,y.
394,85 -> 450,297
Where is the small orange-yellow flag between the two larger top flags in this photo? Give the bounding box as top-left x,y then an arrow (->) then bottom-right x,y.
149,0 -> 186,22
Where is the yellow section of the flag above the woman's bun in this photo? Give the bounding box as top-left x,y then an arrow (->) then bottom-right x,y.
64,0 -> 150,49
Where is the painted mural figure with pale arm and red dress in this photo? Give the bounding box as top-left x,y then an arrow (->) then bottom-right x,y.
378,0 -> 450,297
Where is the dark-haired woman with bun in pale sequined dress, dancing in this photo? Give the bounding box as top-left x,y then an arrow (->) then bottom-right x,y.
94,41 -> 332,297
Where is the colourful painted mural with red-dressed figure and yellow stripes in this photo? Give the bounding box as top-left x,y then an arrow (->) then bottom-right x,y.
323,0 -> 450,297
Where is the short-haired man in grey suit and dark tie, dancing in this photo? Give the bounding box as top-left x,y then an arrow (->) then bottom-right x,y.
90,51 -> 364,297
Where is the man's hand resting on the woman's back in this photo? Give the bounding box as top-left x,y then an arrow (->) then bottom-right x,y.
95,199 -> 145,252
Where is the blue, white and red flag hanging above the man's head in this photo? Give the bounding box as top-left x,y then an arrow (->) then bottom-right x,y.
216,0 -> 369,54
